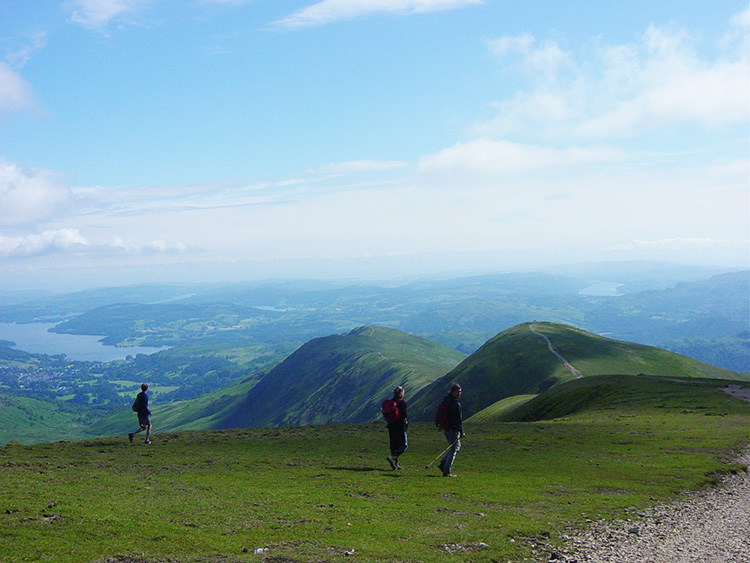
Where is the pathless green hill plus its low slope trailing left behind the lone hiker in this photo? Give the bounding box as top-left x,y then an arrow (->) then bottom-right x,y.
91,326 -> 466,435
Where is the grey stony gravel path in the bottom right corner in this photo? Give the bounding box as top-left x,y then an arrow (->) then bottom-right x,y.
550,449 -> 750,563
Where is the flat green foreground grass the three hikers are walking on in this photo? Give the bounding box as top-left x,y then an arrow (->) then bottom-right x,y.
0,388 -> 750,563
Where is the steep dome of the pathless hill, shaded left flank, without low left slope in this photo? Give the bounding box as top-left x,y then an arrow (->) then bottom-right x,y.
215,327 -> 465,428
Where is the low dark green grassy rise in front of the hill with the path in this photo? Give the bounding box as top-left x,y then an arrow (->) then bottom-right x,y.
482,375 -> 750,422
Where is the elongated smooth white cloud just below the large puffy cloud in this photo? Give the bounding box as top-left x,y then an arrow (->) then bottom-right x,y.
418,139 -> 625,175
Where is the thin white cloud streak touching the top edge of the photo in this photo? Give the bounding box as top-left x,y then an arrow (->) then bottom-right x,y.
276,0 -> 484,28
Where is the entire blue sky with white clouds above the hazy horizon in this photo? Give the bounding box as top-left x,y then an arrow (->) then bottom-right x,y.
0,0 -> 750,290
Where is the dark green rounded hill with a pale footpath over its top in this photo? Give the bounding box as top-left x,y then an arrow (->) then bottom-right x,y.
412,323 -> 750,420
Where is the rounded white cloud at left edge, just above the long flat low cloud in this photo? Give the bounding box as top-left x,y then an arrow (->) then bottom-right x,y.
0,158 -> 71,225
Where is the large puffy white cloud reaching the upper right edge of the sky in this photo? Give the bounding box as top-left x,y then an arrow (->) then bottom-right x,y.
484,13 -> 750,139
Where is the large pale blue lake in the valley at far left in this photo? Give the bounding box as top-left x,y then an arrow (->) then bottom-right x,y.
0,323 -> 166,362
